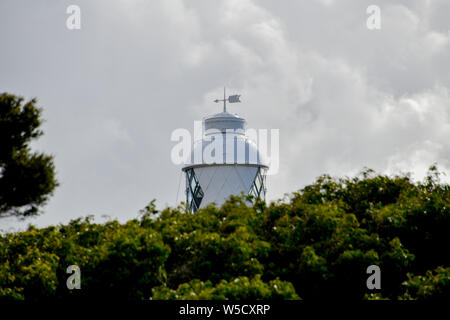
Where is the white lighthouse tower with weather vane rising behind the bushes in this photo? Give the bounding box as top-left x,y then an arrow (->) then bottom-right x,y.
182,89 -> 268,212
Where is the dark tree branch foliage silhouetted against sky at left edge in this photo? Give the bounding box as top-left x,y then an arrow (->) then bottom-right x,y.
0,93 -> 58,218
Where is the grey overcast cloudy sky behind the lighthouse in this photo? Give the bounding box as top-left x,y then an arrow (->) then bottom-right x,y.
0,0 -> 450,231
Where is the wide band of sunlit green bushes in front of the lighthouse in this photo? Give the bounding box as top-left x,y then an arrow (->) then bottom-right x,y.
0,167 -> 450,300
